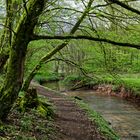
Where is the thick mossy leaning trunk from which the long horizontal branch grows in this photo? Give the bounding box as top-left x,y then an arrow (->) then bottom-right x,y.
0,0 -> 45,120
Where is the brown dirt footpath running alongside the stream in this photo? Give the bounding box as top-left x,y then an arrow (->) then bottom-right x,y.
31,83 -> 104,140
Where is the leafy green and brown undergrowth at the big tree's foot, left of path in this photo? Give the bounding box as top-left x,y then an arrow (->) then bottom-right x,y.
0,96 -> 56,140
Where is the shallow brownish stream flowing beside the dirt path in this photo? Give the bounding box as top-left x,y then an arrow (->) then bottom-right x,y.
44,83 -> 140,140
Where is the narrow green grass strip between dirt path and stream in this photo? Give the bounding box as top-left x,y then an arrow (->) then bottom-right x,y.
76,100 -> 120,140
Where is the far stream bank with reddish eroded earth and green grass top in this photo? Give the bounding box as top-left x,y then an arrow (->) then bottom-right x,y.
49,75 -> 140,106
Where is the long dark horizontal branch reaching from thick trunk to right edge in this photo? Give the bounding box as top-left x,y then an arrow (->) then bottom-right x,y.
32,35 -> 140,49
